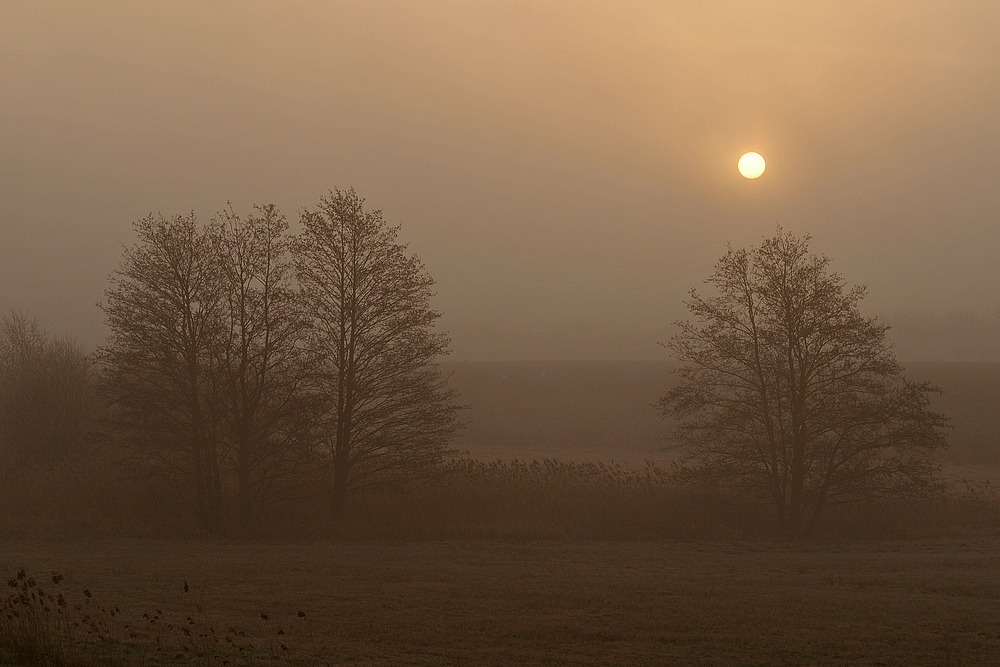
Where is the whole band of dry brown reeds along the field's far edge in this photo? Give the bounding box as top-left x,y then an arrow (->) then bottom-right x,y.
0,458 -> 1000,540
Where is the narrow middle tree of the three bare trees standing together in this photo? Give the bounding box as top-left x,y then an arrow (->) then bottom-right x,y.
217,205 -> 312,532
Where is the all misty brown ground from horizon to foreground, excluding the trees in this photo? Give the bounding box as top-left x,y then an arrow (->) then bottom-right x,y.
0,362 -> 1000,667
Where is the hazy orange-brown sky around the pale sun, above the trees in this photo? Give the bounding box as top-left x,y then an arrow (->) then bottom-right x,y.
0,0 -> 1000,359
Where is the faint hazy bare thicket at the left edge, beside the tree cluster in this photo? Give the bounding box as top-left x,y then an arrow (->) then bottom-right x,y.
0,312 -> 98,466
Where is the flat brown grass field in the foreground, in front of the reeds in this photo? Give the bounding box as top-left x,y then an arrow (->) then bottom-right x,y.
0,540 -> 1000,665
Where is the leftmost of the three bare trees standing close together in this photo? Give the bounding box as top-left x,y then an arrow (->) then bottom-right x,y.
98,213 -> 224,532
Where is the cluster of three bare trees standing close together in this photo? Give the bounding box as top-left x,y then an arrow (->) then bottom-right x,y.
97,190 -> 458,532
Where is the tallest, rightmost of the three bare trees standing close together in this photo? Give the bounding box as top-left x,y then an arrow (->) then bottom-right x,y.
296,189 -> 457,517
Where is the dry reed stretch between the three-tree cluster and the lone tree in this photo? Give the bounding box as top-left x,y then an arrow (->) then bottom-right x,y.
328,458 -> 746,539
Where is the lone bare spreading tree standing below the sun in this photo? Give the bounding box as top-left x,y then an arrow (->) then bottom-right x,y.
659,228 -> 946,536
